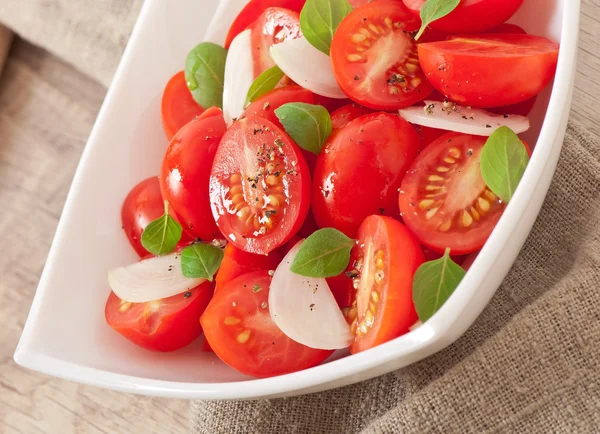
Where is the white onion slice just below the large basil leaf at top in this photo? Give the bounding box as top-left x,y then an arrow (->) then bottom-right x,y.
270,37 -> 348,99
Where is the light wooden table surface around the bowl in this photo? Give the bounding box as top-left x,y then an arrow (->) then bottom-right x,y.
0,0 -> 600,434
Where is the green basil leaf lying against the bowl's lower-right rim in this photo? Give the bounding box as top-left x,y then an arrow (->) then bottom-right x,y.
413,249 -> 466,322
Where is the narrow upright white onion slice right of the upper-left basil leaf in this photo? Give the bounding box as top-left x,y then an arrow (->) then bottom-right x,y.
223,29 -> 254,125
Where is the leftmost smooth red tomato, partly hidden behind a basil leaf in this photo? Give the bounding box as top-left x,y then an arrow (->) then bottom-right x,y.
121,176 -> 194,257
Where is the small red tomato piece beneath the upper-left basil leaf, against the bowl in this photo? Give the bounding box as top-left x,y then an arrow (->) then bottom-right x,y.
162,71 -> 204,140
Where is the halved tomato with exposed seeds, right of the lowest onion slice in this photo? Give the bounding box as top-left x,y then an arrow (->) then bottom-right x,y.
346,216 -> 424,353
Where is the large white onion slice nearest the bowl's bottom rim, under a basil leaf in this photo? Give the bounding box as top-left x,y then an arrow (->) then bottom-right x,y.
269,241 -> 352,350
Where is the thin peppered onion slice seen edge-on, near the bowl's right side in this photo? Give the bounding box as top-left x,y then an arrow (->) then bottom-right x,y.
400,101 -> 529,136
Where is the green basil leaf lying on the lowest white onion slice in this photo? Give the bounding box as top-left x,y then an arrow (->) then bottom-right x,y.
290,228 -> 356,277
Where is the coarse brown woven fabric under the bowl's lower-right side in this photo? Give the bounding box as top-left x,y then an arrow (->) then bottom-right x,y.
192,122 -> 600,434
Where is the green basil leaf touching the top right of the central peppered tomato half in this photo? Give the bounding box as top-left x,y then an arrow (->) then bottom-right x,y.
275,102 -> 333,155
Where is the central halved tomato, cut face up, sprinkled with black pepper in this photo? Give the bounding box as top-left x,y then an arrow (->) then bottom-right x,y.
210,117 -> 310,255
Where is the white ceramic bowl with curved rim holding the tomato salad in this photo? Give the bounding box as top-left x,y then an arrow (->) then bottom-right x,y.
15,0 -> 580,399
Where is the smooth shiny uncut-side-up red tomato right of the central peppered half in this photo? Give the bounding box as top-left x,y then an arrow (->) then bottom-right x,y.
313,113 -> 420,237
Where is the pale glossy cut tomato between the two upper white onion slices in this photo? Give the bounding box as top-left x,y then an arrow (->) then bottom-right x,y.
252,8 -> 302,77
